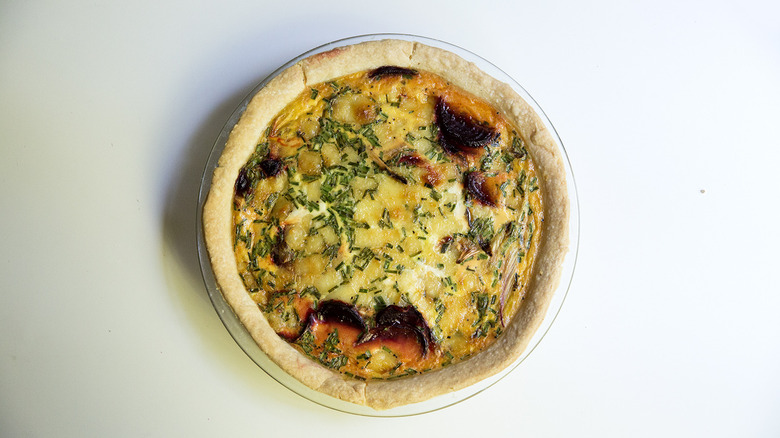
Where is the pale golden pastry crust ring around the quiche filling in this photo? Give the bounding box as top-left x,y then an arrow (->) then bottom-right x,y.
203,40 -> 569,410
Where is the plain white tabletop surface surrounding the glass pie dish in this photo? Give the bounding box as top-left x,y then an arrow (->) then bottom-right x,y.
0,0 -> 780,437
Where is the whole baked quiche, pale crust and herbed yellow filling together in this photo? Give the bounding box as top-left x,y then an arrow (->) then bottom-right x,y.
203,40 -> 568,409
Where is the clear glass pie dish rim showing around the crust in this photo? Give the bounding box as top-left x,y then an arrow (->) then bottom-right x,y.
196,33 -> 580,417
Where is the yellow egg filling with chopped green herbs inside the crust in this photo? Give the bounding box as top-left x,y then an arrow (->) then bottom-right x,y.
233,66 -> 544,379
